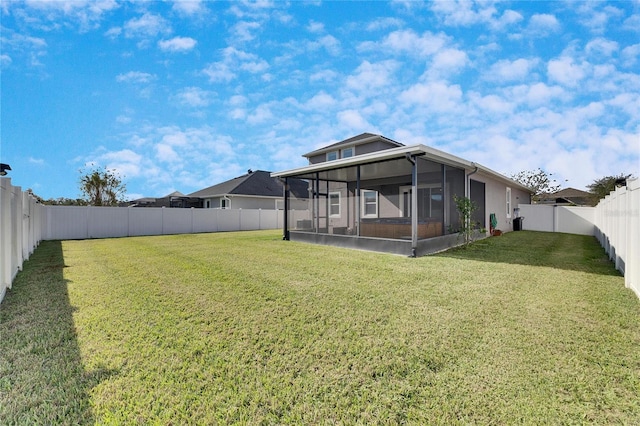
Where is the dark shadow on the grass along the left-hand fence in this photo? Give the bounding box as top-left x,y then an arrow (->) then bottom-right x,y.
0,241 -> 116,424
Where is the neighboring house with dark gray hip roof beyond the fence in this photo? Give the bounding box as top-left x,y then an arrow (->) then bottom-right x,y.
189,170 -> 309,210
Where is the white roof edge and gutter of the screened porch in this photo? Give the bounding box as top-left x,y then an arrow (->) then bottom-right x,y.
271,144 -> 533,193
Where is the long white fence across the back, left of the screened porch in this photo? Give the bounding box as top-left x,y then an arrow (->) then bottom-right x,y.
42,206 -> 283,240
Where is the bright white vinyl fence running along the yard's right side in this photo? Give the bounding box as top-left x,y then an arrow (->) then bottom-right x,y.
595,178 -> 640,297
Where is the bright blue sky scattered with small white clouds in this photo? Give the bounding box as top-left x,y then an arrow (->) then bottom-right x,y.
0,0 -> 640,199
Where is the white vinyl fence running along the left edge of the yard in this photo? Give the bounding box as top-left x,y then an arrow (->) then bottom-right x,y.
0,178 -> 45,302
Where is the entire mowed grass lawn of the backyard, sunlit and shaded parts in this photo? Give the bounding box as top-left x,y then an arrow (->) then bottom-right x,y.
0,231 -> 640,425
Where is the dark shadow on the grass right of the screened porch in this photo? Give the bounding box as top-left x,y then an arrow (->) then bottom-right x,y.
435,231 -> 620,276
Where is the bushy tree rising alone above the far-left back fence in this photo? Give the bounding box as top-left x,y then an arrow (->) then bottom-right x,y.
80,167 -> 127,206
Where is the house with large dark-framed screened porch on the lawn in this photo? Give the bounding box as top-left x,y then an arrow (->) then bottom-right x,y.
271,133 -> 532,256
